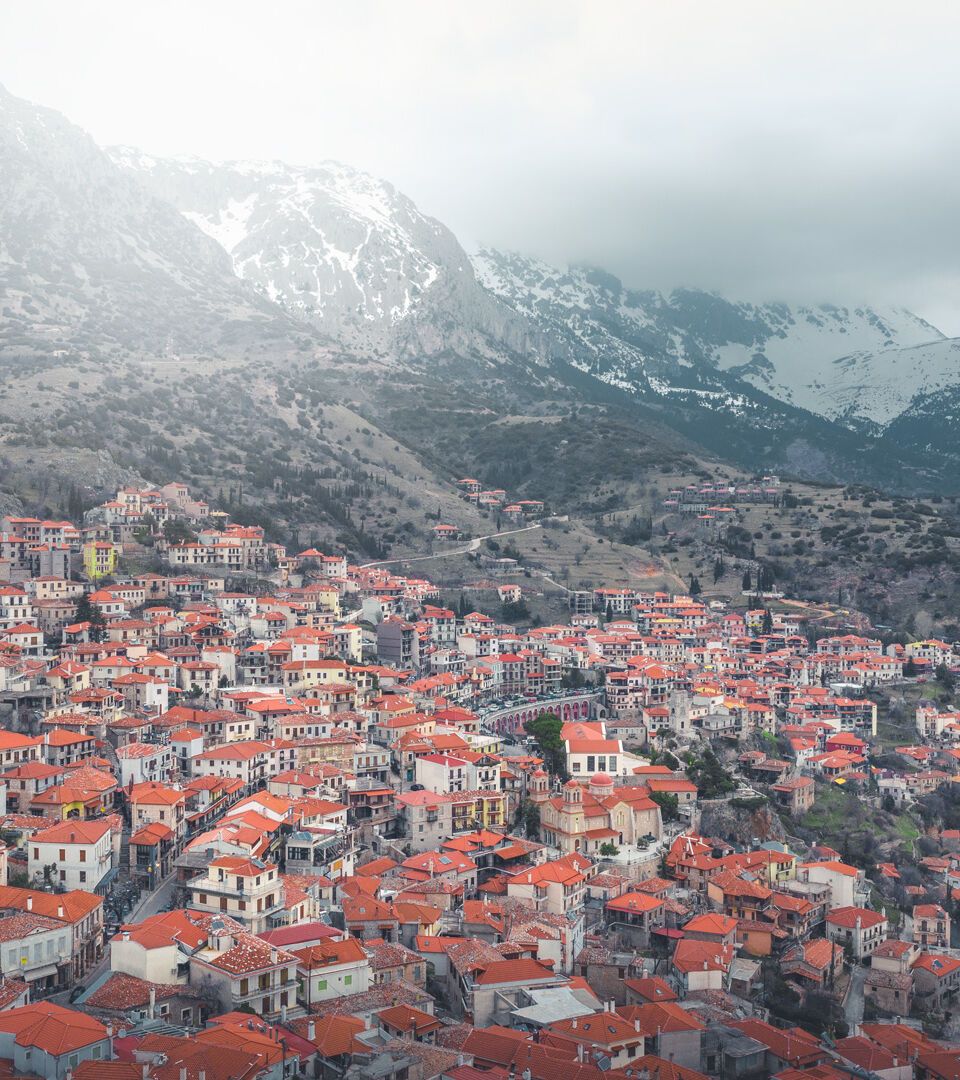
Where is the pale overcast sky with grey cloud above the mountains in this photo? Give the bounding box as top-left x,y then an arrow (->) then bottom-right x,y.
0,0 -> 960,334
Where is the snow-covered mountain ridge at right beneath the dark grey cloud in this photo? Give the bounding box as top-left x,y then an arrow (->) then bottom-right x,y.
473,251 -> 960,427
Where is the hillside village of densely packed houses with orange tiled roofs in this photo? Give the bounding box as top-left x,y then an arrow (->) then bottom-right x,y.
0,477 -> 945,1080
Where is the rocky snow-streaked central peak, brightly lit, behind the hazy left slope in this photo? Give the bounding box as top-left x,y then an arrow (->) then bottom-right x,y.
109,147 -> 543,354
